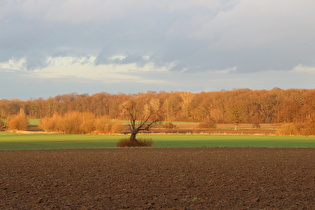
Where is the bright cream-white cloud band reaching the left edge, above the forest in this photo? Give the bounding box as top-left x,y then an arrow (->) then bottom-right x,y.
0,55 -> 170,84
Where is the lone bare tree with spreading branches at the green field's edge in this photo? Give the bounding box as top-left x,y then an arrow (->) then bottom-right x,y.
122,99 -> 161,141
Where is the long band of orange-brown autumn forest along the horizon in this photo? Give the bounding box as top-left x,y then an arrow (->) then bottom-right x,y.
0,88 -> 315,124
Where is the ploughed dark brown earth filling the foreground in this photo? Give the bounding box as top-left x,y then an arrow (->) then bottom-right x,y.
0,148 -> 315,209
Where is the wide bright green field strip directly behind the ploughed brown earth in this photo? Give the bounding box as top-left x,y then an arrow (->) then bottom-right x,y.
0,132 -> 315,150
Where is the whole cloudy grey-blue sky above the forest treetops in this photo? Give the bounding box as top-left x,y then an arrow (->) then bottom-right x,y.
0,0 -> 315,100
